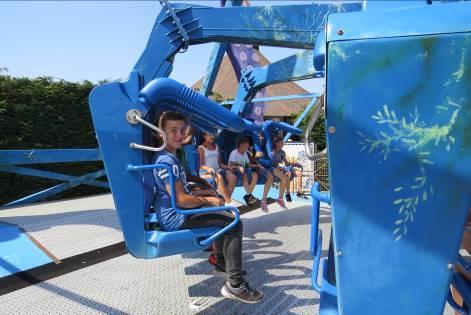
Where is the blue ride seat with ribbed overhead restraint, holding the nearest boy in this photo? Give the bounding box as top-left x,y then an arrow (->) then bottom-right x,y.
89,76 -> 251,259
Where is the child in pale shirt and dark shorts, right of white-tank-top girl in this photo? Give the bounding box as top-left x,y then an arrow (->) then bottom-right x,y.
228,136 -> 263,205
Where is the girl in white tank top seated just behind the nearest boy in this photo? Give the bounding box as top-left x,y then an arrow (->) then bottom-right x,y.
198,133 -> 237,204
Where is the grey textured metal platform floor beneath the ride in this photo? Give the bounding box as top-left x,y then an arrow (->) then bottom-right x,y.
0,195 -> 458,315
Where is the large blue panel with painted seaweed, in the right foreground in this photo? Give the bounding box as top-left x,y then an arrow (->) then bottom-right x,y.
326,25 -> 471,314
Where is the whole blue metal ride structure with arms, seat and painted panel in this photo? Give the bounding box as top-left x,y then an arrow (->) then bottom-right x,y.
90,0 -> 471,314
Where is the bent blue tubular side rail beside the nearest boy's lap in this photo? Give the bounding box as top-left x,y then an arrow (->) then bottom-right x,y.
128,164 -> 240,247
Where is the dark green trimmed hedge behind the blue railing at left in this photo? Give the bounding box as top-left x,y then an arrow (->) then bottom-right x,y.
0,75 -> 108,205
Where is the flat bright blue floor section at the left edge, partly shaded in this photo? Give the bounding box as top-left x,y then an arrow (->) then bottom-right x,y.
0,223 -> 52,278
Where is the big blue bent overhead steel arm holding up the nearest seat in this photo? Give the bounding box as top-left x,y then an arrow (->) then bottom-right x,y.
133,3 -> 362,87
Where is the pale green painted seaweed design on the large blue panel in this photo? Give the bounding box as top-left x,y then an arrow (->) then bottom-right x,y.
357,98 -> 461,241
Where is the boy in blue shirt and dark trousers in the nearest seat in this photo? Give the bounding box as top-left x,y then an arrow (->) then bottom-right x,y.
154,112 -> 263,303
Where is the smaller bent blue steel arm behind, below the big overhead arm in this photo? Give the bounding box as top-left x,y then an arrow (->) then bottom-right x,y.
231,50 -> 323,113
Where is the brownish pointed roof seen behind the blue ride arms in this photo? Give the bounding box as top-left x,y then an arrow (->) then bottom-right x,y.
192,50 -> 310,117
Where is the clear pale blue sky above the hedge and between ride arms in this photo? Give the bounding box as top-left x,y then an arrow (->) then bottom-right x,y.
0,0 -> 323,92
